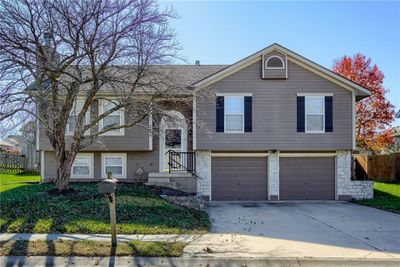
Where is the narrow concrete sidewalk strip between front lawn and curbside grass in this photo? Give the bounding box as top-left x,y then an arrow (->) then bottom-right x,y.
0,233 -> 200,243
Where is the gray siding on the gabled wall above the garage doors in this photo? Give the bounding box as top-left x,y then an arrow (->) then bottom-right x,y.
197,60 -> 352,151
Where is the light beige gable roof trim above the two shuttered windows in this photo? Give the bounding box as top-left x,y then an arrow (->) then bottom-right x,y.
193,43 -> 371,97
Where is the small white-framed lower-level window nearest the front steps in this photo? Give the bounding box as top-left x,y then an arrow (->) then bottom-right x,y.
101,153 -> 126,178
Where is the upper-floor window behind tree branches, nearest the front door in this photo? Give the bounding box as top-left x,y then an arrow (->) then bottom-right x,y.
99,100 -> 124,135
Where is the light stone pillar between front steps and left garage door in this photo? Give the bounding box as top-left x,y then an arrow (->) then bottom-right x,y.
196,150 -> 211,200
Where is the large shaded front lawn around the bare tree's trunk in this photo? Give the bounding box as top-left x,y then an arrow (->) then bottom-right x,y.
0,174 -> 210,234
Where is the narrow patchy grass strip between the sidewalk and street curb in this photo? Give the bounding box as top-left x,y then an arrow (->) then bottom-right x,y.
0,240 -> 186,257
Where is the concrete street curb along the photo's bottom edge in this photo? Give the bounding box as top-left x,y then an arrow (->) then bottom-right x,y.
0,256 -> 399,267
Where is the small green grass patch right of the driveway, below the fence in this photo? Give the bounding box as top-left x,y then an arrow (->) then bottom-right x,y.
356,182 -> 400,213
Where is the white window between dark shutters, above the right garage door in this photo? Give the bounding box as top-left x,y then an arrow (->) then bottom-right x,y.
305,96 -> 325,133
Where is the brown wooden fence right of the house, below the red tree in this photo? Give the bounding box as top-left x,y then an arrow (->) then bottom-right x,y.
355,153 -> 400,182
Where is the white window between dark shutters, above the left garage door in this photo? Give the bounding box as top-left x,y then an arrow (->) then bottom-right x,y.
225,96 -> 244,133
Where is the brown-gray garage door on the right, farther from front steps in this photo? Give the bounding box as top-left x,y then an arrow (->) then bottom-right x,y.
279,157 -> 335,200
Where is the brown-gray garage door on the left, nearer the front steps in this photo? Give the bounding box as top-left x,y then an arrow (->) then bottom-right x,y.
211,157 -> 267,200
